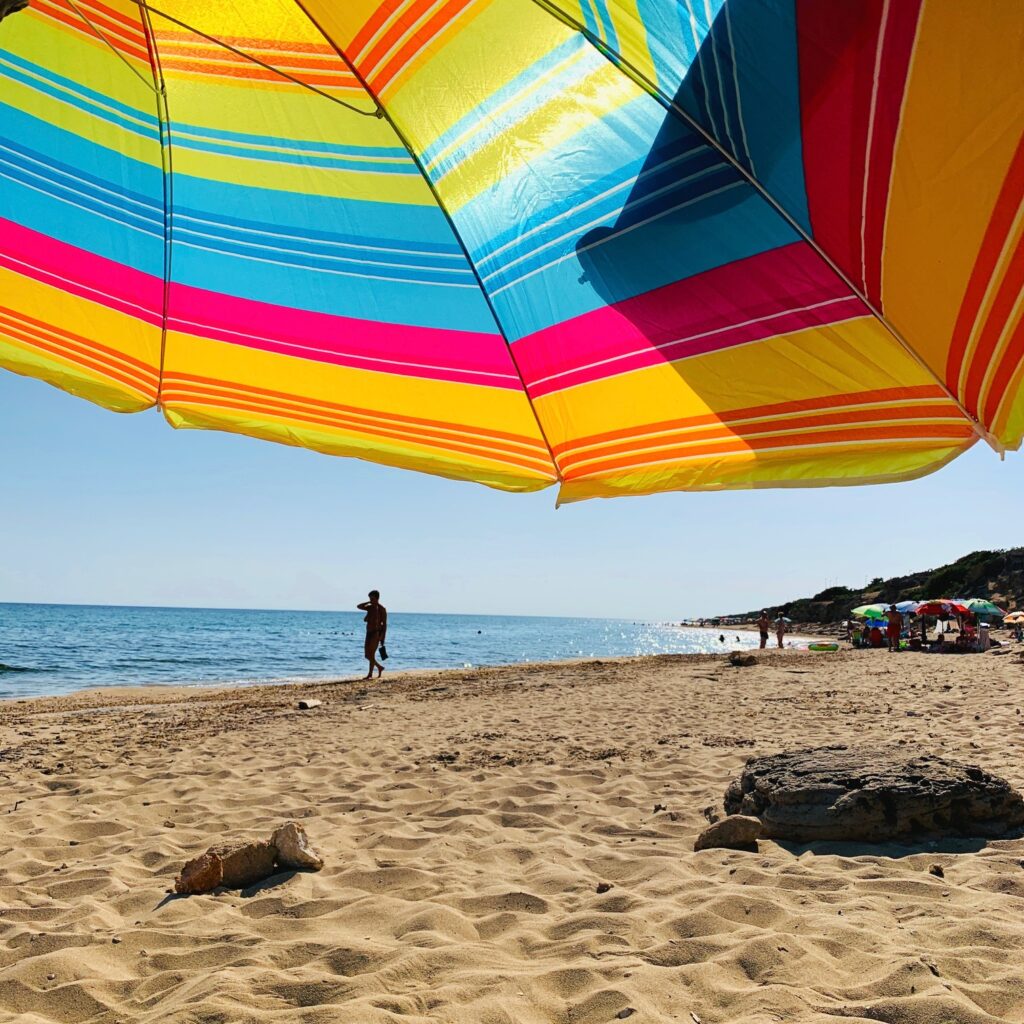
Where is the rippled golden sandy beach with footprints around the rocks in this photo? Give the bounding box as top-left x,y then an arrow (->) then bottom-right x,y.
0,651 -> 1024,1024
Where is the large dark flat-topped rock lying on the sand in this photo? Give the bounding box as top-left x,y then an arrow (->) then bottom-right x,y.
725,745 -> 1024,843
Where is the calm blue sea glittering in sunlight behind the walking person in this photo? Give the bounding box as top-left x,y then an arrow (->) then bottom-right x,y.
0,603 -> 757,697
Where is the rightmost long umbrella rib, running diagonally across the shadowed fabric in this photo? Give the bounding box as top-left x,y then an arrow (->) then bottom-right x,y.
532,0 -> 1006,456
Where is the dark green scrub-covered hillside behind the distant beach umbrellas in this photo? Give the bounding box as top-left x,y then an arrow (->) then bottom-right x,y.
741,548 -> 1024,623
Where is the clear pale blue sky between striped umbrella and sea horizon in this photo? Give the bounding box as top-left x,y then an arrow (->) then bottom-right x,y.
0,371 -> 1024,620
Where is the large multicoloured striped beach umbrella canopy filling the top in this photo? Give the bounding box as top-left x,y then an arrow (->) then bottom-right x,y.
0,0 -> 1024,501
